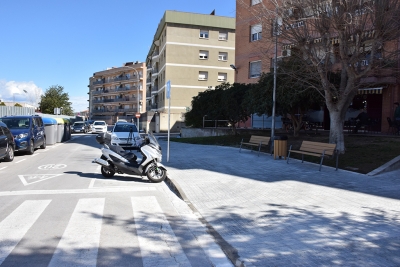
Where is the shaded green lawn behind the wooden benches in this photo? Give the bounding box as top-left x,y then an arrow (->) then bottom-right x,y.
171,131 -> 400,173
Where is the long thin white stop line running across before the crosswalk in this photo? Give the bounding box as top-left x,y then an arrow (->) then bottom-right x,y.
0,186 -> 157,197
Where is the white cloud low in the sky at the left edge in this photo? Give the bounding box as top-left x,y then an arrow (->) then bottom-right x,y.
0,80 -> 43,105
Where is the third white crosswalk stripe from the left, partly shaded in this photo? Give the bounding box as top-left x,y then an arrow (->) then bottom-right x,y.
131,196 -> 191,267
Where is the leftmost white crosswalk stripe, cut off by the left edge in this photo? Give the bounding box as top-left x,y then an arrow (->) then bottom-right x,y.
0,200 -> 51,264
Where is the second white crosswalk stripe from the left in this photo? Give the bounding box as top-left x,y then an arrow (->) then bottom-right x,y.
48,198 -> 105,267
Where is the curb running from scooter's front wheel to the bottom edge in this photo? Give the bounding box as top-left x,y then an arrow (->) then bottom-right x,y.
165,176 -> 253,267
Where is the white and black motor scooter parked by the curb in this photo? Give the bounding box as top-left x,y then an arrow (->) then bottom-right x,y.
93,132 -> 167,183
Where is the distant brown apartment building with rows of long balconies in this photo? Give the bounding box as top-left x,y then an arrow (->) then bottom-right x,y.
88,61 -> 147,125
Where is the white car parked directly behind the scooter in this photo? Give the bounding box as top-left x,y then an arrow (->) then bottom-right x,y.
110,122 -> 143,150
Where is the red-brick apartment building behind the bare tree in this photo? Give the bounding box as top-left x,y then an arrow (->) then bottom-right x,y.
235,0 -> 400,131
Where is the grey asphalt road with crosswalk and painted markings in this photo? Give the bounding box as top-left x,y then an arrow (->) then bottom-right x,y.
0,134 -> 232,266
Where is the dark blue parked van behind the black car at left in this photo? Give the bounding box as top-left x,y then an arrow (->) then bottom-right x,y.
0,115 -> 46,155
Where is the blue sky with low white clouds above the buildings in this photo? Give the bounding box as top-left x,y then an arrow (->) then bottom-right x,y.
0,0 -> 236,112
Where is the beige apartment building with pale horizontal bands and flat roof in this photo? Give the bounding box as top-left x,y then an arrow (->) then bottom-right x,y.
146,11 -> 235,132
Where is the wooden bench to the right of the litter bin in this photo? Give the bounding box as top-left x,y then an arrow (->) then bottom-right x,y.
286,141 -> 339,171
